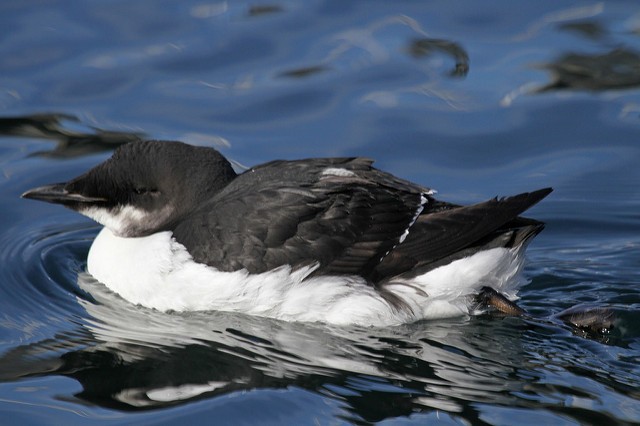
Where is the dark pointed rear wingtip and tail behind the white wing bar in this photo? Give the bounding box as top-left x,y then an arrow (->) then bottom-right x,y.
375,188 -> 552,281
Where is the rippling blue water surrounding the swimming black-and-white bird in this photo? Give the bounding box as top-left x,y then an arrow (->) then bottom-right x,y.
0,0 -> 640,424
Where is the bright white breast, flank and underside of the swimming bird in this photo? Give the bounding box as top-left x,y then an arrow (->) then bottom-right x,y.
88,228 -> 523,326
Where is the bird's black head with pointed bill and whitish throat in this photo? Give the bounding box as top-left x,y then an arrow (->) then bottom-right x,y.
22,141 -> 236,237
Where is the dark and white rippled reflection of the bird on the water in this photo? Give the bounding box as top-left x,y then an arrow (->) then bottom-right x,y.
0,274 -> 536,421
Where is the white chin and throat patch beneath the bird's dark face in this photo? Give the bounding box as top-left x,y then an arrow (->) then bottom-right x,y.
78,206 -> 151,237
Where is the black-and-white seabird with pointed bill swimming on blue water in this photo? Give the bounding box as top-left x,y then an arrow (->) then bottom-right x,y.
22,140 -> 552,327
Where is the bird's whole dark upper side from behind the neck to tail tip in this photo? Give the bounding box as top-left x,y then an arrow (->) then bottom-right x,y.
174,158 -> 551,284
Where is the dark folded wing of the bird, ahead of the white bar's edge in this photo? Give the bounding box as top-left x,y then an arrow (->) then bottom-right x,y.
174,158 -> 429,277
